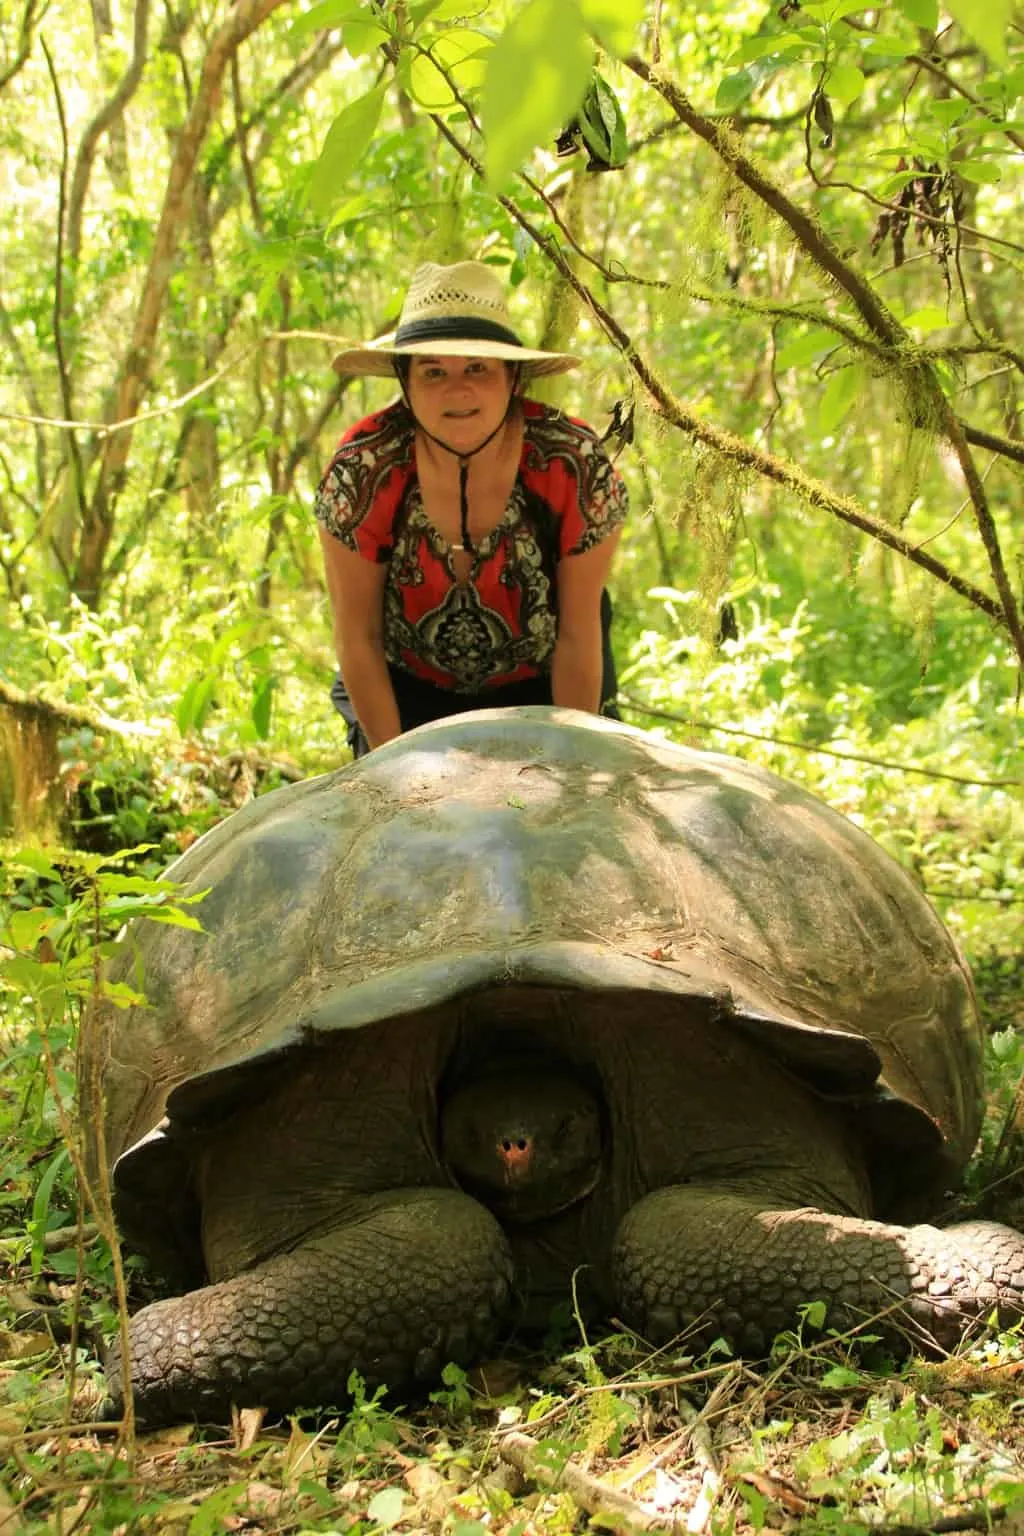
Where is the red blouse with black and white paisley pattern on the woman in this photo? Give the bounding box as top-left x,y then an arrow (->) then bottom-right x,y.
316,401 -> 628,693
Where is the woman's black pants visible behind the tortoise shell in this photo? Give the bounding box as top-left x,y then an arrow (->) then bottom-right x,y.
330,591 -> 620,757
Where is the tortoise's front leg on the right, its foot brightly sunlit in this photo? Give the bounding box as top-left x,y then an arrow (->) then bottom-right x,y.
614,1186 -> 1024,1353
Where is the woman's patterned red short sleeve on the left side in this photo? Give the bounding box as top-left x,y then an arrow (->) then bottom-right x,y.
313,406 -> 413,564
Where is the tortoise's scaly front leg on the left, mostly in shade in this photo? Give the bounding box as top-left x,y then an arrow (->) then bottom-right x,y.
107,1189 -> 511,1424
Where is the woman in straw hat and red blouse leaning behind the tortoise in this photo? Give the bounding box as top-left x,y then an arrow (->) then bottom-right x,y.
316,261 -> 628,756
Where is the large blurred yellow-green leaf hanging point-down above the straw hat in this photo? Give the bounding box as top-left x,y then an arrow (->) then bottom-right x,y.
482,0 -> 594,189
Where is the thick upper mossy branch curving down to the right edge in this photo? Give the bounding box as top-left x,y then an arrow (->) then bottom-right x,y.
626,54 -> 1024,667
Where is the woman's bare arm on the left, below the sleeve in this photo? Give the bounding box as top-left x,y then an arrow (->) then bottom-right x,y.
319,527 -> 402,746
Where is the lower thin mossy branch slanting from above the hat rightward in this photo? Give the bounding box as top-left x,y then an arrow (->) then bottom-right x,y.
433,117 -> 1007,629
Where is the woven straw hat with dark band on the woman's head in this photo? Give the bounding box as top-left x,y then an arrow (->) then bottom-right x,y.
332,261 -> 579,378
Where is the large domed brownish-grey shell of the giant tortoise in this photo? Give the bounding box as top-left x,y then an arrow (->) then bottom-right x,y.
100,707 -> 981,1243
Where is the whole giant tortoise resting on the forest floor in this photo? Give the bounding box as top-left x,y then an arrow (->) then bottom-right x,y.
90,708 -> 1024,1422
